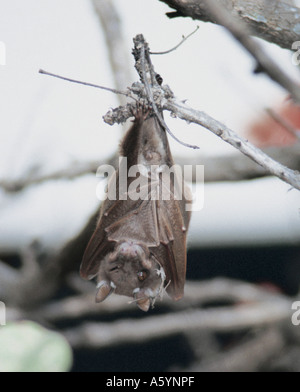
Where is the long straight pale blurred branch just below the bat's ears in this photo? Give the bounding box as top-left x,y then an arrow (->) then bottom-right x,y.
64,301 -> 291,349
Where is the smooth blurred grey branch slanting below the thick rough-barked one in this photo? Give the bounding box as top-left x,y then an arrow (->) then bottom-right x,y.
203,0 -> 300,104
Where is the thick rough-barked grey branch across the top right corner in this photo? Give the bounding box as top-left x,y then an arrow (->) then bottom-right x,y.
160,0 -> 300,49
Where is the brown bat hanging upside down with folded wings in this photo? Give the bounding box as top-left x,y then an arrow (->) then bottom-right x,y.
80,107 -> 191,311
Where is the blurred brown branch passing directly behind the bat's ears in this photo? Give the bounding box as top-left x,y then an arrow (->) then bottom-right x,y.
25,275 -> 287,323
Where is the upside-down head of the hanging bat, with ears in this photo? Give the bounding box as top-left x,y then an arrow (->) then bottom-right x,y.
96,241 -> 166,312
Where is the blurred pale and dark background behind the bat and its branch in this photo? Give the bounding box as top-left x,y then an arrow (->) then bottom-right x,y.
0,0 -> 300,372
